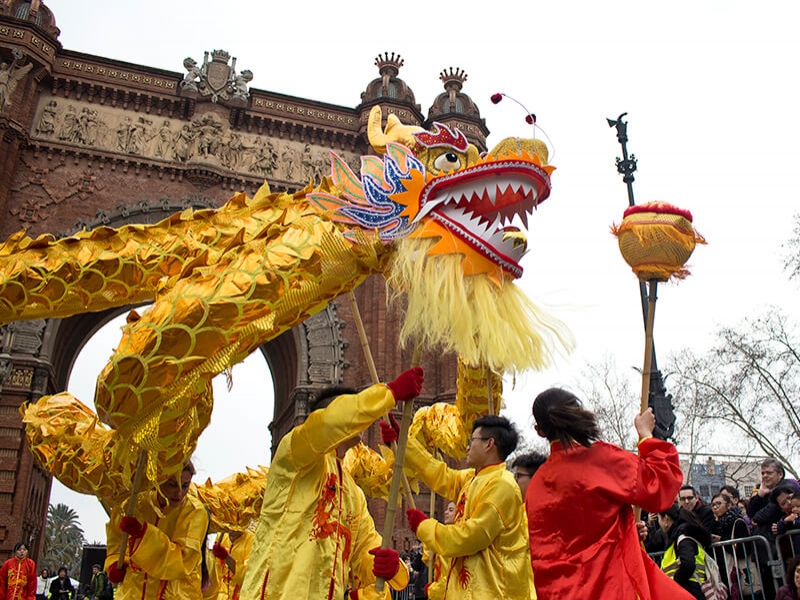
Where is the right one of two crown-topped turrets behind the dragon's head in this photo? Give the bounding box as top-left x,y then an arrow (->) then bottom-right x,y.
424,67 -> 489,150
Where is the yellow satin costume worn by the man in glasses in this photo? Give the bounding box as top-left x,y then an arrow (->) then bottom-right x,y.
406,439 -> 536,600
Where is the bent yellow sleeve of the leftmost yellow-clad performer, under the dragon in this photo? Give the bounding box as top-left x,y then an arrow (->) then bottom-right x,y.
131,505 -> 208,581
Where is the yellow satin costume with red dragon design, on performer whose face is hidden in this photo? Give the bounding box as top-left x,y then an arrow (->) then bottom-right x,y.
241,384 -> 408,600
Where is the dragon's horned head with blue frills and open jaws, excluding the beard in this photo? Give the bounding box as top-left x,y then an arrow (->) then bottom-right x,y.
312,106 -> 554,284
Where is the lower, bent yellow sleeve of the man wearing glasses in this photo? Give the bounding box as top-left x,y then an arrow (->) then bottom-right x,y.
417,479 -> 522,558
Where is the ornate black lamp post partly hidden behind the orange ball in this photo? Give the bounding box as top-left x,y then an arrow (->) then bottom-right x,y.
606,113 -> 675,440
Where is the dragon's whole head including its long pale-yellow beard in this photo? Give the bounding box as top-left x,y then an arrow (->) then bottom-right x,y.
306,106 -> 569,370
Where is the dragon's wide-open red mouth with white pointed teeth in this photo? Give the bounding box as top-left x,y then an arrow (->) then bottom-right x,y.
414,158 -> 550,278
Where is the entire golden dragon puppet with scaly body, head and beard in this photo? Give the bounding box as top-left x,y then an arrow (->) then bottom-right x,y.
0,107 -> 569,596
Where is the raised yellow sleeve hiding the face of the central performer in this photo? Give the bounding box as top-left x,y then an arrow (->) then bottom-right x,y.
289,383 -> 394,468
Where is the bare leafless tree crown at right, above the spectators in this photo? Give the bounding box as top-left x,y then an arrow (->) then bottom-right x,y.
668,309 -> 800,477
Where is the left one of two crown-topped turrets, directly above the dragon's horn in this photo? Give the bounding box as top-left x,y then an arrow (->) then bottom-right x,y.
356,52 -> 424,132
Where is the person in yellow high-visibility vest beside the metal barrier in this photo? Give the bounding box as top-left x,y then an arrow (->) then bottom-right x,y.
658,504 -> 711,600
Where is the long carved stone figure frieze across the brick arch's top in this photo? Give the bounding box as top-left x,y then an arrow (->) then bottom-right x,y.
31,96 -> 360,184
